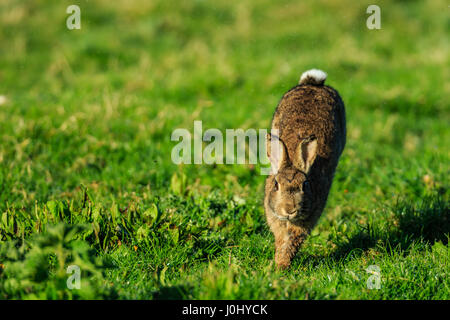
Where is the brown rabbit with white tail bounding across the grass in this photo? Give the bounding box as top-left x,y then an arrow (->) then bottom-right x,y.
264,69 -> 346,268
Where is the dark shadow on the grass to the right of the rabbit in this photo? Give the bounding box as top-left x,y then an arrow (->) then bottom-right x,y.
322,196 -> 450,261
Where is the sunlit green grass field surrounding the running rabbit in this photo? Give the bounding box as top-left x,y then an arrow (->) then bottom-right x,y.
0,0 -> 450,299
